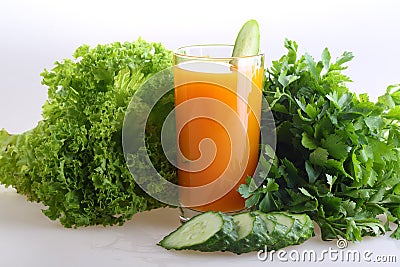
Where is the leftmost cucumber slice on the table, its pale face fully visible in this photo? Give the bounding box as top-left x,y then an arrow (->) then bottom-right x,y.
159,211 -> 238,251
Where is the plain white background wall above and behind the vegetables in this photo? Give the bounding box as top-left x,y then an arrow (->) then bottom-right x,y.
0,0 -> 400,132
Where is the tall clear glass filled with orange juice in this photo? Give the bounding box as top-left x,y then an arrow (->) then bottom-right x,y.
174,45 -> 264,221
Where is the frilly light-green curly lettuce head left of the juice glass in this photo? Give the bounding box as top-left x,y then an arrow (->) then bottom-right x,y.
0,39 -> 176,227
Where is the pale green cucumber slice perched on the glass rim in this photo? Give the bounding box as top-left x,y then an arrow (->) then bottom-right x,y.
232,20 -> 260,57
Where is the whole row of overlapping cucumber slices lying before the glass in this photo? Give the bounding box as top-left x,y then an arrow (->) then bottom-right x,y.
159,211 -> 314,254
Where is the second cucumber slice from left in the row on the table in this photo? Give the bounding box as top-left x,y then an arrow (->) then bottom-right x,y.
228,212 -> 268,254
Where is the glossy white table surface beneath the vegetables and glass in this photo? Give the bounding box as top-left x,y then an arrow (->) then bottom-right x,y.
0,185 -> 400,267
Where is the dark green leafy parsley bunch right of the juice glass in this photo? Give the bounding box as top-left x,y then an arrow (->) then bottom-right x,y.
239,40 -> 400,241
